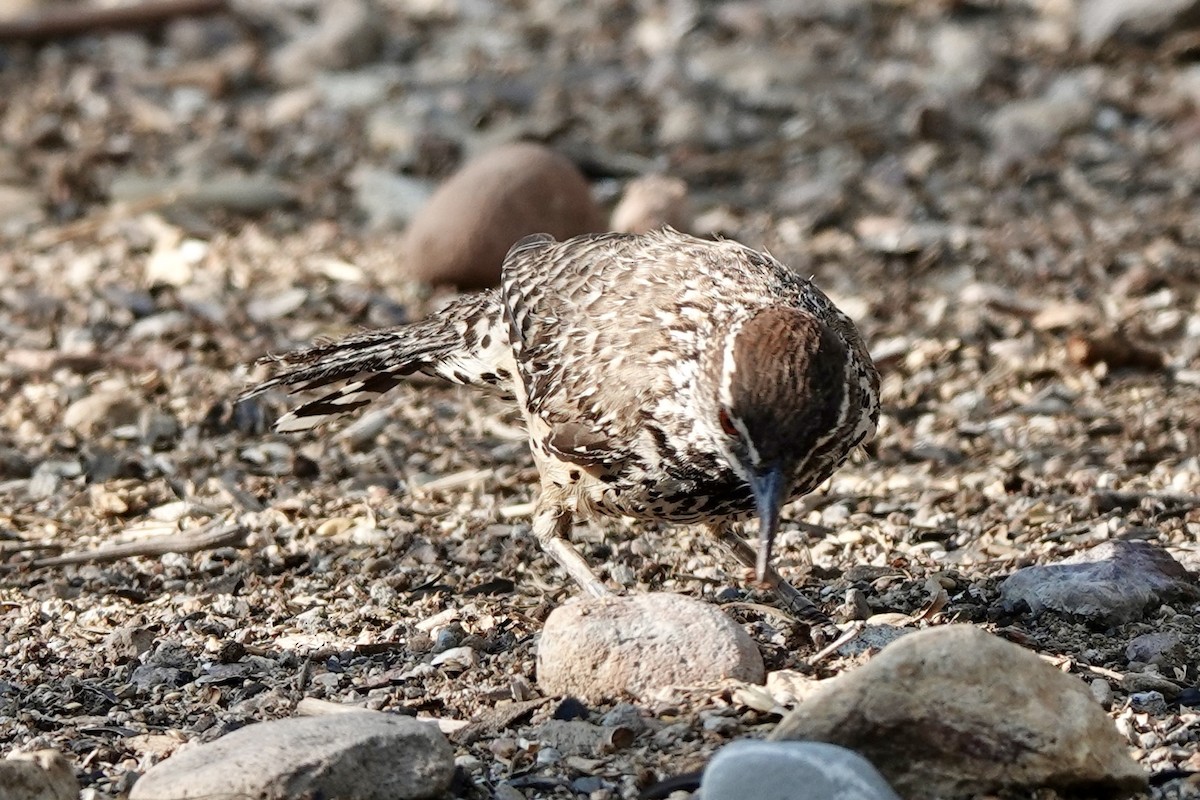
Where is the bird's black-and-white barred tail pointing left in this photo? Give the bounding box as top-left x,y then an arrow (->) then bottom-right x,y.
238,290 -> 511,431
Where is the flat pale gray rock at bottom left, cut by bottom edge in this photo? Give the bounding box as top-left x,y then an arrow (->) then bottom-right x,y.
130,711 -> 454,800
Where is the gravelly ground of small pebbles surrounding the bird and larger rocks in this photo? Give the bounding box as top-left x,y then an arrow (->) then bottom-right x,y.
0,0 -> 1200,800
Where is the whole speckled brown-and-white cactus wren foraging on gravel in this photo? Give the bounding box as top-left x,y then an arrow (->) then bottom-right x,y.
240,228 -> 880,624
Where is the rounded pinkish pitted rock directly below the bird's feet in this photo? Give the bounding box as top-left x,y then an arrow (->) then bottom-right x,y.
538,594 -> 764,700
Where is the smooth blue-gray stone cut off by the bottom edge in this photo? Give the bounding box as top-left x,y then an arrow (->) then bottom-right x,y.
700,740 -> 899,800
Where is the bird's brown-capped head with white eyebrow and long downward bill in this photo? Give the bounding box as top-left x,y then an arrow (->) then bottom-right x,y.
709,306 -> 847,581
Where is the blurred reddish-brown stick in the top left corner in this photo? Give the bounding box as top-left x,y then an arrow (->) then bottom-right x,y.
0,0 -> 228,42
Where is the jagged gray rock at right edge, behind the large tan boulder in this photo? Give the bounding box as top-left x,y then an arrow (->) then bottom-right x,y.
1000,541 -> 1196,625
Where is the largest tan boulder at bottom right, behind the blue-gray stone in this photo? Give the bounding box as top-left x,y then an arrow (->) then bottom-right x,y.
772,625 -> 1147,799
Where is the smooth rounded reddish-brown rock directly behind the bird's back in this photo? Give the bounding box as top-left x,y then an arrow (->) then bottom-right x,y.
400,144 -> 605,289
